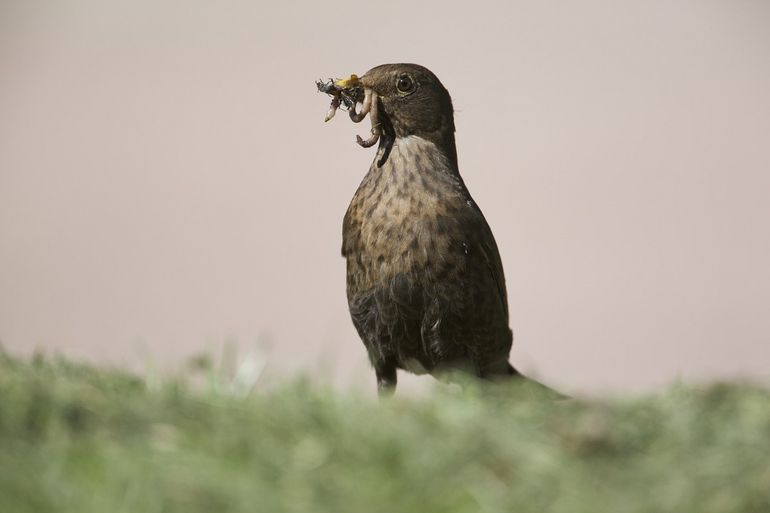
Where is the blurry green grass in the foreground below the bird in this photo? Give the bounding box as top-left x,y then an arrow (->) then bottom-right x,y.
0,353 -> 770,513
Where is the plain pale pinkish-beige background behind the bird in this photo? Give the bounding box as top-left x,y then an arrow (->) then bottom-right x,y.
0,0 -> 770,393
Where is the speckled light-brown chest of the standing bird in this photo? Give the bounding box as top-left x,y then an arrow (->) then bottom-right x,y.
343,145 -> 468,289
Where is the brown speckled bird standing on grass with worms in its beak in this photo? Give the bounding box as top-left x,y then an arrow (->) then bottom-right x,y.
338,63 -> 522,396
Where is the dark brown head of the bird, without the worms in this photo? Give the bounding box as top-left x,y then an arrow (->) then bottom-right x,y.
360,64 -> 455,142
